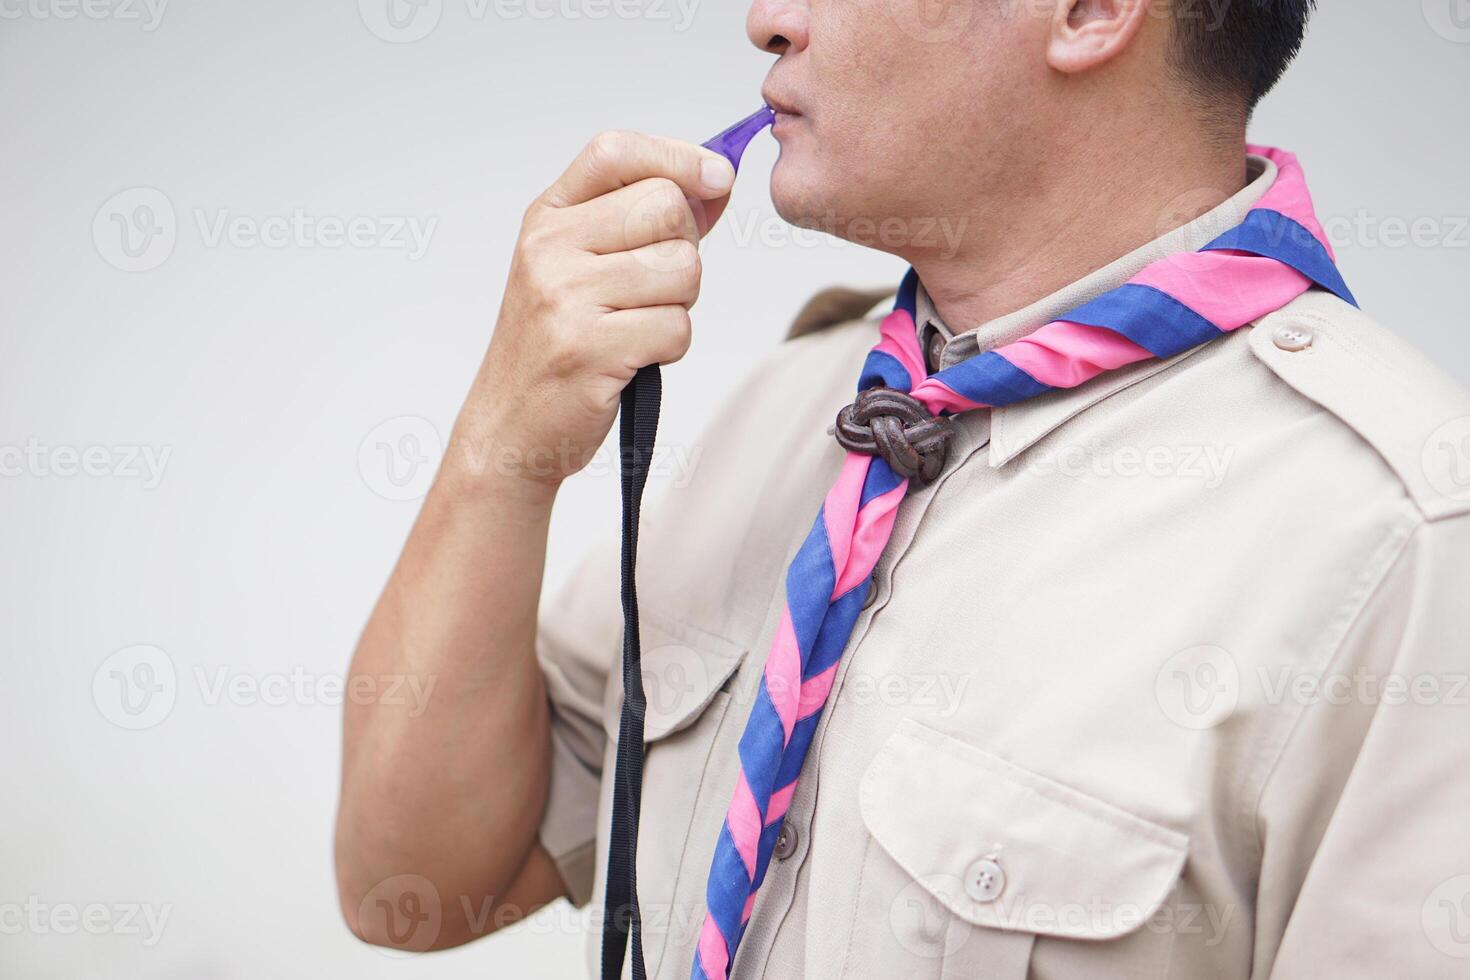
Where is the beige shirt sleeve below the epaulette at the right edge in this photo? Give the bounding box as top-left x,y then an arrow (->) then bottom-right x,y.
1258,516 -> 1470,980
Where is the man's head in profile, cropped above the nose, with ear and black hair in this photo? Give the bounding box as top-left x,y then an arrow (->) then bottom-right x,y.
748,0 -> 1314,260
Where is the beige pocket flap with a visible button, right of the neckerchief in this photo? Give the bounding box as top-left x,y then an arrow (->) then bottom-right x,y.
860,720 -> 1189,939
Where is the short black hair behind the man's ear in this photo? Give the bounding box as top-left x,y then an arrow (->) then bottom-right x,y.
1173,0 -> 1317,112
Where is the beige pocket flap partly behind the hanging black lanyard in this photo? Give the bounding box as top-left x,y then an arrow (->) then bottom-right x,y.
632,610 -> 745,742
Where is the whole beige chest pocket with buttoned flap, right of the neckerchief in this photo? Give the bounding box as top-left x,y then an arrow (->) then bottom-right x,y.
848,720 -> 1188,980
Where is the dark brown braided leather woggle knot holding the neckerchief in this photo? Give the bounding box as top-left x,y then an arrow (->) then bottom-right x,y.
835,388 -> 954,483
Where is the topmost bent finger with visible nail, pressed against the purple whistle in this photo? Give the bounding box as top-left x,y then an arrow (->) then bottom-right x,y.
542,132 -> 735,207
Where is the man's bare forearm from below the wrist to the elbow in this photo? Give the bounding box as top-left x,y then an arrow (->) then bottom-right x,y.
337,439 -> 554,933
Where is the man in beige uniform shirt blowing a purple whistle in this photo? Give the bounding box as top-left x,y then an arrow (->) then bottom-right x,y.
337,0 -> 1470,980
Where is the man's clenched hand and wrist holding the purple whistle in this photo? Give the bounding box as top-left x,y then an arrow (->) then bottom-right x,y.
457,132 -> 735,485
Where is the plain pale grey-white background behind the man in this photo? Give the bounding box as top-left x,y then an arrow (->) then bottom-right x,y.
0,0 -> 1470,980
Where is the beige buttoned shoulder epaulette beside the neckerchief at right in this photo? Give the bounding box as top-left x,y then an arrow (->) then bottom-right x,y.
1250,291 -> 1470,520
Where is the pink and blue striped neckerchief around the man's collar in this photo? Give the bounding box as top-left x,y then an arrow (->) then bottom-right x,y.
691,147 -> 1357,980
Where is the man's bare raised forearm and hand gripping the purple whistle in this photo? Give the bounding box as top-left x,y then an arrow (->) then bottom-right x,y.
337,134 -> 735,949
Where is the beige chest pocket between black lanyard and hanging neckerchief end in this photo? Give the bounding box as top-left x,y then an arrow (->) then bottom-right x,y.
594,610 -> 747,980
